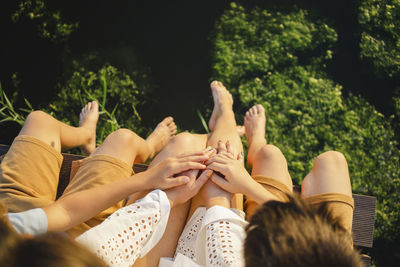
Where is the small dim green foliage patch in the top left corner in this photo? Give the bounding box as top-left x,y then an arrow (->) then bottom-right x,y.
11,0 -> 78,42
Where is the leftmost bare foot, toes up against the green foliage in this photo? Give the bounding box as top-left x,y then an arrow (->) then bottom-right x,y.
79,101 -> 99,155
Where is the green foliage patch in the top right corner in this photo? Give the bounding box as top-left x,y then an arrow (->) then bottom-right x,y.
358,0 -> 400,77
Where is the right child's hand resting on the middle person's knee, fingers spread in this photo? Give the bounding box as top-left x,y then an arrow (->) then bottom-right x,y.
206,142 -> 255,195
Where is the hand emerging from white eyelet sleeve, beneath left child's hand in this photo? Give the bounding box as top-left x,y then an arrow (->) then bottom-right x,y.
165,170 -> 212,207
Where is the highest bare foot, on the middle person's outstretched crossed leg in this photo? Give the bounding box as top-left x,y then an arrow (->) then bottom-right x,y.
208,81 -> 233,131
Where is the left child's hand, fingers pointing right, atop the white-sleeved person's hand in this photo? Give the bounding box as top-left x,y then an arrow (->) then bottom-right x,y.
146,149 -> 213,189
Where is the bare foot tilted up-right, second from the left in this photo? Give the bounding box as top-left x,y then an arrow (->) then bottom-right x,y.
146,117 -> 176,158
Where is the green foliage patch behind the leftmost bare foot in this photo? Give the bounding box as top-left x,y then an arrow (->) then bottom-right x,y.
49,62 -> 149,143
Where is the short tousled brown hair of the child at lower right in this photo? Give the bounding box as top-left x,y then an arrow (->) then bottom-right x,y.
244,196 -> 362,267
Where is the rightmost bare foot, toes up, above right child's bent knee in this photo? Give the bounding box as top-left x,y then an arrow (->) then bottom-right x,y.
244,104 -> 267,166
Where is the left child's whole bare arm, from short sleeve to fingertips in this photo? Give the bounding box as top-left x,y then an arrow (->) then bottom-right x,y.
43,151 -> 209,231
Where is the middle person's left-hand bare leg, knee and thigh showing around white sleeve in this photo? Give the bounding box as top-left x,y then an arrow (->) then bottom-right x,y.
133,133 -> 207,266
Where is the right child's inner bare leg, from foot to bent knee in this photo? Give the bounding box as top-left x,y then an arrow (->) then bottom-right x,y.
244,105 -> 293,216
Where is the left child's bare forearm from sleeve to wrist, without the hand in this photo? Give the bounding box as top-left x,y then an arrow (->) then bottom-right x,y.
43,173 -> 147,231
